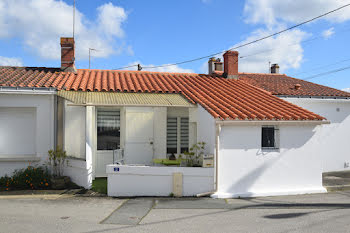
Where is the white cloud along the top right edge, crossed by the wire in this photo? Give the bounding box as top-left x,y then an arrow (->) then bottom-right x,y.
244,0 -> 350,26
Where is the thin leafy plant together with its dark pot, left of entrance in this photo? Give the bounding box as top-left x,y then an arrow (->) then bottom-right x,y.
48,146 -> 70,189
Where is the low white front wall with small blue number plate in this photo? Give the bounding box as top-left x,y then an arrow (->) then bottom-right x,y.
107,165 -> 214,197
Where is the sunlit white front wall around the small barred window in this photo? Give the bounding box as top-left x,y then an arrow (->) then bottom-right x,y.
214,124 -> 325,198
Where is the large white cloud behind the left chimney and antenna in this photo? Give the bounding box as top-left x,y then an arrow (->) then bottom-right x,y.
0,0 -> 127,59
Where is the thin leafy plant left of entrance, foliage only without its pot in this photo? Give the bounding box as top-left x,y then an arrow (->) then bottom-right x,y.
48,146 -> 68,177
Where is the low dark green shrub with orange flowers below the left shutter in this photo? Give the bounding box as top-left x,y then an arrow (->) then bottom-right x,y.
0,166 -> 51,191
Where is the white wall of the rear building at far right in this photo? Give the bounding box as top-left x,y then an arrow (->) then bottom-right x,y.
283,98 -> 350,172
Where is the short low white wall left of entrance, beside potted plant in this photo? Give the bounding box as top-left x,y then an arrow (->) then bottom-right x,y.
63,158 -> 92,189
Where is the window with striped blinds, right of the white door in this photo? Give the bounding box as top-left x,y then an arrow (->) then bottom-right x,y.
167,117 -> 189,154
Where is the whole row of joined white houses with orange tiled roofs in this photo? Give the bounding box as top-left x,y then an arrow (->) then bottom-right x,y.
0,38 -> 350,198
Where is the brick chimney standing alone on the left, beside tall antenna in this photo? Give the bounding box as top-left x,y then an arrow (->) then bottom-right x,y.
61,37 -> 77,72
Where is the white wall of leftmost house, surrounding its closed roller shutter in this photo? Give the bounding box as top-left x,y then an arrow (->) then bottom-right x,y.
0,91 -> 55,177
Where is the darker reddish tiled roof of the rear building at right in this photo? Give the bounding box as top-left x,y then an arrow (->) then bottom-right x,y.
239,73 -> 350,97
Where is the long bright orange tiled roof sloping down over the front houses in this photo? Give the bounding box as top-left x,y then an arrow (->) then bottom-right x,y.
0,67 -> 324,120
